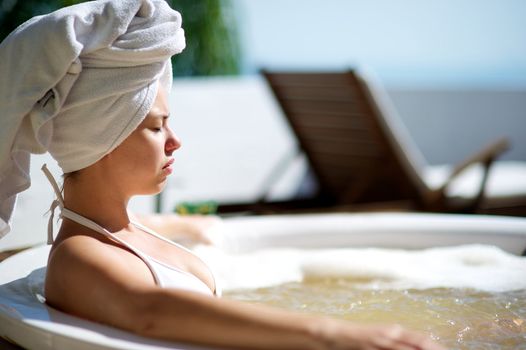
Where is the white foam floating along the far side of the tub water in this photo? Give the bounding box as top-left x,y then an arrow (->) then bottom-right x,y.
196,245 -> 526,292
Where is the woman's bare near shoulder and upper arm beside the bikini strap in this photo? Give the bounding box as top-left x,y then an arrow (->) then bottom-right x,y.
45,235 -> 156,330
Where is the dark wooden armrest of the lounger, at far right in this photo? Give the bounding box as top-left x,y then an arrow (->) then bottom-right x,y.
427,137 -> 510,209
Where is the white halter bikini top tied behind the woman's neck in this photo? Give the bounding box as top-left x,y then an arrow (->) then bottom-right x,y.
42,164 -> 221,297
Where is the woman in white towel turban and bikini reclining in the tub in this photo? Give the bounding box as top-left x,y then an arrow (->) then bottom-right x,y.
0,0 -> 441,349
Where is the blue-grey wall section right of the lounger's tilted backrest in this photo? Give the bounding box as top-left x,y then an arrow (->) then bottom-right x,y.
389,88 -> 526,164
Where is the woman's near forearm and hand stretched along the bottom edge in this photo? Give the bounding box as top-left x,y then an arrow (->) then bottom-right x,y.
130,289 -> 442,350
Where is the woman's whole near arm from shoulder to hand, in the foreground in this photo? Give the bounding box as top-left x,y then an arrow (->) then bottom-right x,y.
46,236 -> 441,350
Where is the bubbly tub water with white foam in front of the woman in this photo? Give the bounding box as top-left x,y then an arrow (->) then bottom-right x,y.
197,245 -> 526,349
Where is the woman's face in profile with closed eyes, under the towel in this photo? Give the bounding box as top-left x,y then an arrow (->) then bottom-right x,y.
104,86 -> 181,196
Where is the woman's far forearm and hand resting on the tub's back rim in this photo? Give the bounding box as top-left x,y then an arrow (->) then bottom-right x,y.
135,214 -> 221,244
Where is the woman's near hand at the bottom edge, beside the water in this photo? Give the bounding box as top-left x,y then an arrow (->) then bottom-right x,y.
319,319 -> 445,350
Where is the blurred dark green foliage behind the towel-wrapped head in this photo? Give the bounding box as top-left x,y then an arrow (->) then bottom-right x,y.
0,0 -> 241,76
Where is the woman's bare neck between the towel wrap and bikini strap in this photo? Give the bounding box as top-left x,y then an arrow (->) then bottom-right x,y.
64,173 -> 130,232
